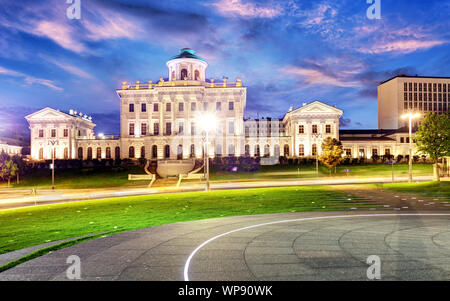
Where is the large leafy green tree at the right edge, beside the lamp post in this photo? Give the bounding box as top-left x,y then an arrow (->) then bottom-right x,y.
414,113 -> 450,181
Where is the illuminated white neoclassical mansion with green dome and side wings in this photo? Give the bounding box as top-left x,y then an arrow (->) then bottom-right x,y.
26,48 -> 422,160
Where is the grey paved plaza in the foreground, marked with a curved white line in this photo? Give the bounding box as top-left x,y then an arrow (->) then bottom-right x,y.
0,210 -> 450,280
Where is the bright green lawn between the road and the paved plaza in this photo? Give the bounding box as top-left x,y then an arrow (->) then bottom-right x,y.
0,186 -> 379,254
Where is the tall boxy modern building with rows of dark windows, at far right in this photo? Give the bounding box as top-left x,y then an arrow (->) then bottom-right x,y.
378,75 -> 450,129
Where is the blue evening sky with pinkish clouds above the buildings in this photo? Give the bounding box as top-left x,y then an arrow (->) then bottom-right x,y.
0,0 -> 450,134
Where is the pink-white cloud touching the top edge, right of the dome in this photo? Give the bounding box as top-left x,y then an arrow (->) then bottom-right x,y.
211,0 -> 283,18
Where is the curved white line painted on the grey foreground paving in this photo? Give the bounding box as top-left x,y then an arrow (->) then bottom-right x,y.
184,213 -> 450,281
